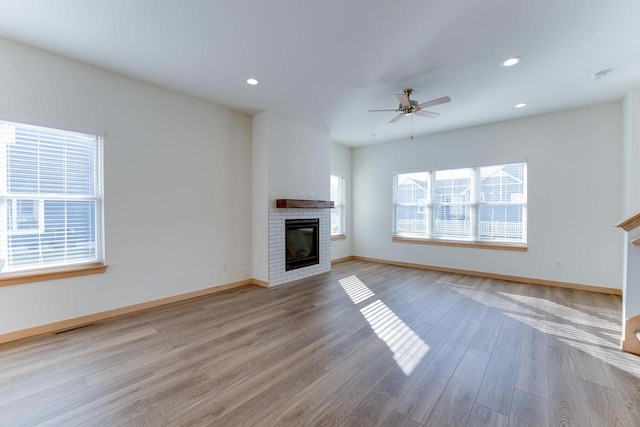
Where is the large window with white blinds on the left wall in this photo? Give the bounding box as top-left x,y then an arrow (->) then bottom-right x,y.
0,121 -> 103,273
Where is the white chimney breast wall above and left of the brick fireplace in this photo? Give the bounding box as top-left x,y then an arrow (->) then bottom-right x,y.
253,111 -> 330,282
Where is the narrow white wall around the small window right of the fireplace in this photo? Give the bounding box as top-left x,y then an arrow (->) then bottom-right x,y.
330,142 -> 353,259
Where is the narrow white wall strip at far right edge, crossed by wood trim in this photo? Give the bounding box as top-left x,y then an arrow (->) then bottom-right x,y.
619,88 -> 640,319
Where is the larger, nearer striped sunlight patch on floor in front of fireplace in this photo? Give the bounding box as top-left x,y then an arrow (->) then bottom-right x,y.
360,300 -> 429,376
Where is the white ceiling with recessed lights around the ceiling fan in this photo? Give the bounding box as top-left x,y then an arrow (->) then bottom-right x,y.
0,0 -> 640,146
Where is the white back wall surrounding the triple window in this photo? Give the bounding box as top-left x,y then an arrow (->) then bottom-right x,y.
353,102 -> 622,288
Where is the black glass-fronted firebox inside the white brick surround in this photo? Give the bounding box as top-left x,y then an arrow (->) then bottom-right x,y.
284,218 -> 320,271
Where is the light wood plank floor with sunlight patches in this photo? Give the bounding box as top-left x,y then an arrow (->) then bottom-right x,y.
0,261 -> 640,427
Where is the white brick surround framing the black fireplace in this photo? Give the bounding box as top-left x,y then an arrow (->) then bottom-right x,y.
269,208 -> 331,287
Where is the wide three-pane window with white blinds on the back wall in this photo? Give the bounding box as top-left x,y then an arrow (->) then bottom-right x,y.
394,163 -> 527,244
